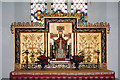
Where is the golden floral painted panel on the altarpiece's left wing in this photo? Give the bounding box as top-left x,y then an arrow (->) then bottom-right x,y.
20,33 -> 44,64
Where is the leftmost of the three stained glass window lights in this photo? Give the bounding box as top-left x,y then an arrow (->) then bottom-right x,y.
31,0 -> 47,23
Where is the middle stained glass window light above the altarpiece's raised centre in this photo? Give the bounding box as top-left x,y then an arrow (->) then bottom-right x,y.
51,0 -> 67,13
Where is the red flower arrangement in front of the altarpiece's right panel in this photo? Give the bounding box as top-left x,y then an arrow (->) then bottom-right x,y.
70,55 -> 84,70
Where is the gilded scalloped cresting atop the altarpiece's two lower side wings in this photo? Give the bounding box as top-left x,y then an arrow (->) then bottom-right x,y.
10,19 -> 110,34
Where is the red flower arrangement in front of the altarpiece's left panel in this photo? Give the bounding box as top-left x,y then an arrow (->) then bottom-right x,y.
35,55 -> 49,70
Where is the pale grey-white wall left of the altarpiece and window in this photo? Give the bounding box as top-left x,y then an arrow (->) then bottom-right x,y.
2,2 -> 30,78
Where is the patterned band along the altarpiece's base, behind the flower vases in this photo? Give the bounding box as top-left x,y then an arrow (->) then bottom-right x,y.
19,63 -> 99,70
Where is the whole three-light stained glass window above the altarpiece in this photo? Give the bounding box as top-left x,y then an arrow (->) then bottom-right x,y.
31,0 -> 87,24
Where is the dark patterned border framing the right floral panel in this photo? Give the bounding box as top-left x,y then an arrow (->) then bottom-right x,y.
76,27 -> 107,68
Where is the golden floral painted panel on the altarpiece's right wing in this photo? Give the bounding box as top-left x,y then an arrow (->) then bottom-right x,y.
77,33 -> 101,64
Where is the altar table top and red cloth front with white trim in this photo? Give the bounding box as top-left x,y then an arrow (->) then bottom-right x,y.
10,69 -> 115,80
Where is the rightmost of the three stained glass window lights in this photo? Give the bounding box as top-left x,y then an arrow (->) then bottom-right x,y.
71,0 -> 87,22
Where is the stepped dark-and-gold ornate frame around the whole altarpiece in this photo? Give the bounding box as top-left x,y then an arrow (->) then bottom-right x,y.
10,17 -> 110,70
